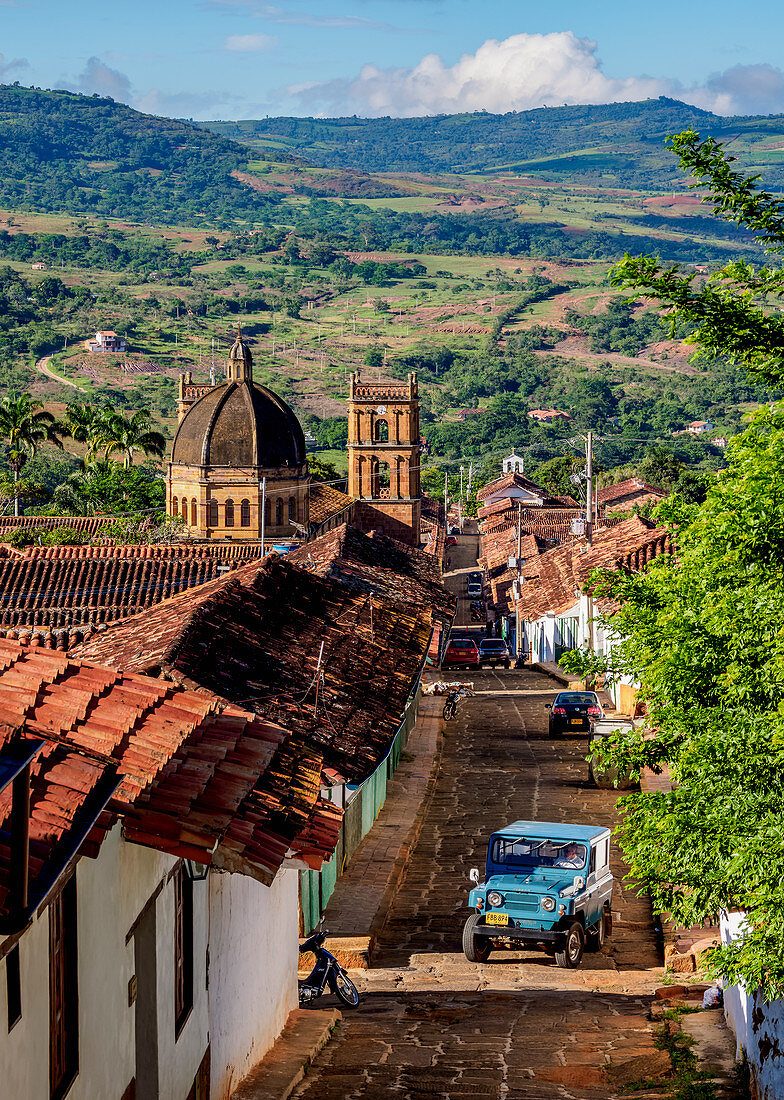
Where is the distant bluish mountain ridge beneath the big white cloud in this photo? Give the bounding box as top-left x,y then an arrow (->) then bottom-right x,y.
199,97 -> 784,190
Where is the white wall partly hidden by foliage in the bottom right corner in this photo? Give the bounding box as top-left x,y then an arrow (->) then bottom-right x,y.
719,912 -> 784,1100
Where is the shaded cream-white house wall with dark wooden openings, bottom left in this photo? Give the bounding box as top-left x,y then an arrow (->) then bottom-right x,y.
0,825 -> 208,1100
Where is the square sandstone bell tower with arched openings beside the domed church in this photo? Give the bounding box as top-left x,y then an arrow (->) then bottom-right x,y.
349,371 -> 421,546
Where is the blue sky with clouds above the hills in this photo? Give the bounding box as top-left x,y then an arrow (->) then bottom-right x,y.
0,0 -> 784,120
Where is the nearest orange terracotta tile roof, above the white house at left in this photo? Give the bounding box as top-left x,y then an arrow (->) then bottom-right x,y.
0,640 -> 340,913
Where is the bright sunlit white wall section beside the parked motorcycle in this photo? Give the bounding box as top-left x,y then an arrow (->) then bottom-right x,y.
210,869 -> 299,1100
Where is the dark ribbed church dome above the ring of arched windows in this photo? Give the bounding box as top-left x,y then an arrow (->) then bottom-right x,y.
172,382 -> 306,469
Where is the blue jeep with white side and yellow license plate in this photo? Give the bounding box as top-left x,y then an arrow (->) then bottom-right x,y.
463,822 -> 612,968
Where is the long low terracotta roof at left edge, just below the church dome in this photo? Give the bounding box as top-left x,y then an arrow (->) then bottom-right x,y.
0,542 -> 266,647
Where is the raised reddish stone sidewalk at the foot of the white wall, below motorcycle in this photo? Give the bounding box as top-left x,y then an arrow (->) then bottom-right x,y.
231,1009 -> 343,1100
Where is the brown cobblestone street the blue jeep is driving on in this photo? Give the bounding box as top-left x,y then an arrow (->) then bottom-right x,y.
295,670 -> 662,1100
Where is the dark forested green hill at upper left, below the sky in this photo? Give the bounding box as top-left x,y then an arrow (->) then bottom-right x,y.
0,85 -> 278,226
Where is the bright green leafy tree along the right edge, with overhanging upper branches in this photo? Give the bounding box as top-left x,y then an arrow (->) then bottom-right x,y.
596,131 -> 784,999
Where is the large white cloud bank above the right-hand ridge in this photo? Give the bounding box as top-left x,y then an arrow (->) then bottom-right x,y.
287,31 -> 784,117
